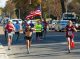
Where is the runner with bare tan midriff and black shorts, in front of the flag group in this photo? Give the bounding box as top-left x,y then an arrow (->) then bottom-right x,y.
25,26 -> 32,54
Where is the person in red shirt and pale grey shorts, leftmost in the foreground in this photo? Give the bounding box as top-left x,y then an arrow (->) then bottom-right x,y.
5,20 -> 15,50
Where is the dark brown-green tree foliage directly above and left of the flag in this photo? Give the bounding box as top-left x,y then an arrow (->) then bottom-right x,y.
13,0 -> 38,19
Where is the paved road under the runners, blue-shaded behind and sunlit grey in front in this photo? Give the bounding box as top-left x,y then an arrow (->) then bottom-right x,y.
0,25 -> 80,59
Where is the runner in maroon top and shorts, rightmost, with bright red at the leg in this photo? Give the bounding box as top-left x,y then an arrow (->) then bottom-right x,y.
66,21 -> 77,53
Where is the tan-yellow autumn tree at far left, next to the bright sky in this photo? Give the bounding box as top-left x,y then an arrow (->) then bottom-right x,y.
3,0 -> 16,18
